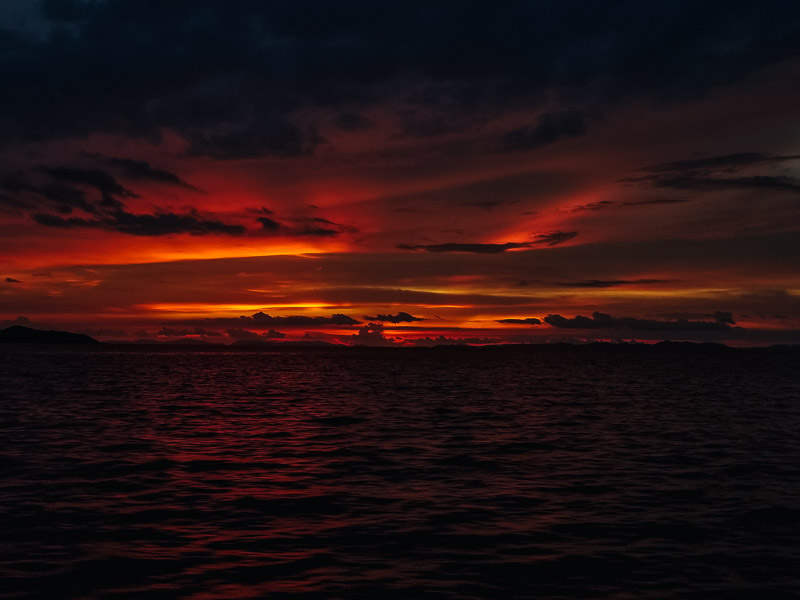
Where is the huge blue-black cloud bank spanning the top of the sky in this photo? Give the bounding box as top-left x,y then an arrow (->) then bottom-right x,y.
0,0 -> 800,158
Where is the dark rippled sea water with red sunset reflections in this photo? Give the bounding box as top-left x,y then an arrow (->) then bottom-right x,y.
0,346 -> 800,600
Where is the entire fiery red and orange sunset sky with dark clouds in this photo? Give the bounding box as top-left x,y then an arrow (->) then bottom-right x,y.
0,0 -> 800,346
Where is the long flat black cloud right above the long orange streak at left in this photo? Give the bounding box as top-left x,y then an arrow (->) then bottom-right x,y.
33,209 -> 246,236
